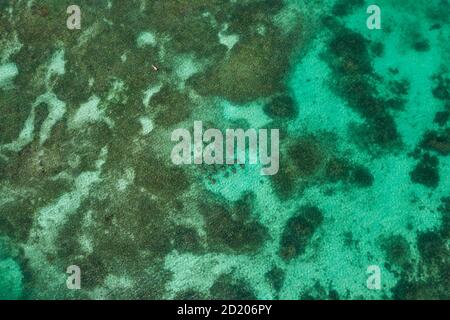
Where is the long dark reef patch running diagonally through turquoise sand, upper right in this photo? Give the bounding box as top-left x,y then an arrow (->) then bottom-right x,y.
327,24 -> 404,147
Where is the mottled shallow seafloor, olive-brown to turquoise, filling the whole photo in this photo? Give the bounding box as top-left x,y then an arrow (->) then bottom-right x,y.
0,0 -> 450,299
